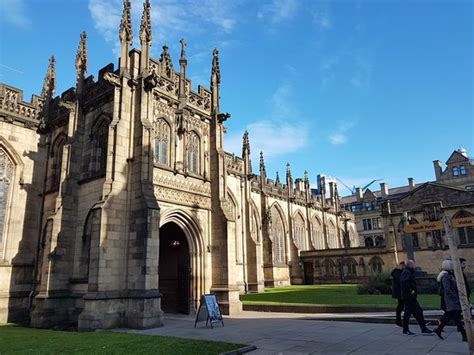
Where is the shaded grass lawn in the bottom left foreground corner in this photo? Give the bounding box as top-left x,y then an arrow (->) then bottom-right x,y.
0,325 -> 243,354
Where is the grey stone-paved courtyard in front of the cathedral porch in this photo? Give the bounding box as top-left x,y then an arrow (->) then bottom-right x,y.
119,312 -> 469,355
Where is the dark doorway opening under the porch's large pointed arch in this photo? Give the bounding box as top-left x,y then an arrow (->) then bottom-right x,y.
158,222 -> 191,314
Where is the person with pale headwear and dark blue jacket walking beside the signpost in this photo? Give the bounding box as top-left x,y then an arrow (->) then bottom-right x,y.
434,260 -> 467,341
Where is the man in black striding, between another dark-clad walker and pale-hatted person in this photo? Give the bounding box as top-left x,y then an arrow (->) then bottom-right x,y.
400,260 -> 433,335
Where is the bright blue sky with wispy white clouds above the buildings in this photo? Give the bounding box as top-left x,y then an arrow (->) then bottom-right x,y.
0,0 -> 474,194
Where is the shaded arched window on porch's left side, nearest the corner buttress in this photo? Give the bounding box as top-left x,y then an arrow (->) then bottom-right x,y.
89,116 -> 109,176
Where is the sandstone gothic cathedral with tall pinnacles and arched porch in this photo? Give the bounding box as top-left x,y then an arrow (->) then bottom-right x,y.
0,0 -> 359,330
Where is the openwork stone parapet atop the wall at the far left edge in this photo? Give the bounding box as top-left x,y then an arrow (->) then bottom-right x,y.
0,83 -> 43,129
